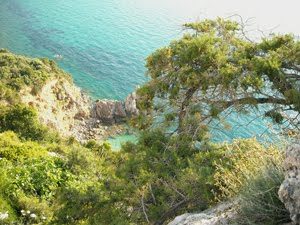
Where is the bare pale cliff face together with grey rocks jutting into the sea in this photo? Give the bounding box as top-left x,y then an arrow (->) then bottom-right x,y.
21,78 -> 138,141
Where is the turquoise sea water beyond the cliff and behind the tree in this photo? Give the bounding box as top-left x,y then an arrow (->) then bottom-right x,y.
0,0 -> 282,148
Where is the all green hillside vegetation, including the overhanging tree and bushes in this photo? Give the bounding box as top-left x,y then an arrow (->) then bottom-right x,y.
0,19 -> 300,225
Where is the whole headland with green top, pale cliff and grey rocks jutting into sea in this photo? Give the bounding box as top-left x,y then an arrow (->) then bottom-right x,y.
0,49 -> 138,141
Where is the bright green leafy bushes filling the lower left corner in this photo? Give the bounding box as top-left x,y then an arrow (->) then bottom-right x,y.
0,132 -> 111,224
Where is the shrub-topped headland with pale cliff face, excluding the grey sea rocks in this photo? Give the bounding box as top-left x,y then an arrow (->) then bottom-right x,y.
0,50 -> 91,140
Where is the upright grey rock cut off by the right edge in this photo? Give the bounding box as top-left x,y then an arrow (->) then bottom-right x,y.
278,143 -> 300,224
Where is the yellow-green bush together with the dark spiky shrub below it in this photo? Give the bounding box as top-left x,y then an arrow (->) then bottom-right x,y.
214,139 -> 290,225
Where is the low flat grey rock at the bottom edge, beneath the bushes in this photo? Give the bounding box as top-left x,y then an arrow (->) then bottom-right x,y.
168,202 -> 236,225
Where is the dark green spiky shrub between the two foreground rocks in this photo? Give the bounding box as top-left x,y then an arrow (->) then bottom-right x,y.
235,164 -> 290,225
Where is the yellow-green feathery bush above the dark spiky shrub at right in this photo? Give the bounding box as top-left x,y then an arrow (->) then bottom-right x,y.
213,139 -> 283,200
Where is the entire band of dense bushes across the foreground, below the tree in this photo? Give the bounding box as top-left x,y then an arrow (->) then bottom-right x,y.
0,127 -> 286,225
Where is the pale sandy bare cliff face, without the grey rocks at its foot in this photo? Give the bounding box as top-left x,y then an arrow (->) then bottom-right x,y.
21,79 -> 91,140
